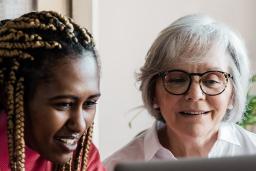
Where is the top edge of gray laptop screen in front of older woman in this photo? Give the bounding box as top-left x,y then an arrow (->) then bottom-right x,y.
114,155 -> 256,171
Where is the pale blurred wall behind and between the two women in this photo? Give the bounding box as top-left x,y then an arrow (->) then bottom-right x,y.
0,0 -> 256,159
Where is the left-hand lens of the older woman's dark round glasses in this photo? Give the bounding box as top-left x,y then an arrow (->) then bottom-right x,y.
164,71 -> 190,95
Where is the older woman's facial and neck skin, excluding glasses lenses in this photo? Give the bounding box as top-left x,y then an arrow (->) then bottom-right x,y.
155,49 -> 232,157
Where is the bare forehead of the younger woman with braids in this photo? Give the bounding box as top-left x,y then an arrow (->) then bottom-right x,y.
38,56 -> 99,96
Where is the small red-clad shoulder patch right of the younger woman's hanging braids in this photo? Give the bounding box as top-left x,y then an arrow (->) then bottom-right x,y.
88,143 -> 105,171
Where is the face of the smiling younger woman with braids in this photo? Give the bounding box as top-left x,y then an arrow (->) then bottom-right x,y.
25,53 -> 100,163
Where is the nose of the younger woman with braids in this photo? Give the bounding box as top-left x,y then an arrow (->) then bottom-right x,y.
67,109 -> 86,133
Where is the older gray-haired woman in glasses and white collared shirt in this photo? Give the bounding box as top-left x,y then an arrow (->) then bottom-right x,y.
105,15 -> 256,170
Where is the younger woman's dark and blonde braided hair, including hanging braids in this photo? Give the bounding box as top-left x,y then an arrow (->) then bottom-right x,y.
0,11 -> 94,171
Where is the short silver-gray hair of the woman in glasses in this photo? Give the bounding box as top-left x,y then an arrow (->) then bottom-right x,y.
138,14 -> 250,122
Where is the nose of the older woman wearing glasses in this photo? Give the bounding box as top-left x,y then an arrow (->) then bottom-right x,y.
185,79 -> 205,101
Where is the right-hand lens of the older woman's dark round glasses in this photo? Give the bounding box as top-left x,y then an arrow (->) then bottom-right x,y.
200,71 -> 227,95
